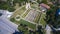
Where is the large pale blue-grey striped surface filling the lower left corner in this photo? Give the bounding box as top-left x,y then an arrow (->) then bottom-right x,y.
0,10 -> 18,34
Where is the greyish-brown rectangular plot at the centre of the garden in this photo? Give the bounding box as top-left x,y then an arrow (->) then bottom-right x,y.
25,10 -> 40,22
